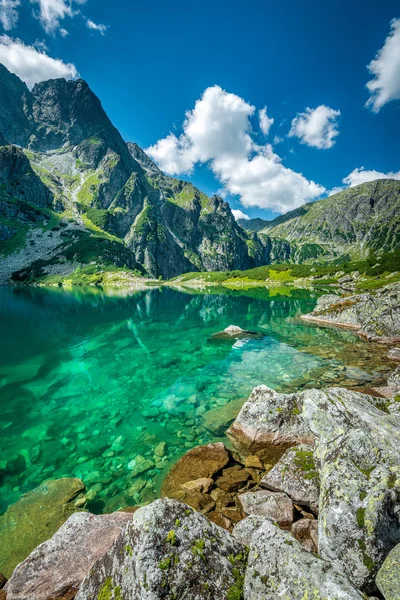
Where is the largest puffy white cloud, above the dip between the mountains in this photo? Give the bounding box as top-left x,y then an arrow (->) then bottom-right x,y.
146,85 -> 325,212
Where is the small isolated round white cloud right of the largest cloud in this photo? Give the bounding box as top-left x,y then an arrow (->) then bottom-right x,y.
289,104 -> 340,150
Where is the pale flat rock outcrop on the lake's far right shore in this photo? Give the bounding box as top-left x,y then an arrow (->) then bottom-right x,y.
302,283 -> 400,342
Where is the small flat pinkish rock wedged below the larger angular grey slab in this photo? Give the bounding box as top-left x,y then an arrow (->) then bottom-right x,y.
238,490 -> 293,529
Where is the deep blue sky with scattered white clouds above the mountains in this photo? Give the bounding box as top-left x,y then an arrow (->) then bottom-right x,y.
0,0 -> 400,218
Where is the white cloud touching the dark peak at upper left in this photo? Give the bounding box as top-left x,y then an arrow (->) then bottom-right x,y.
0,35 -> 79,88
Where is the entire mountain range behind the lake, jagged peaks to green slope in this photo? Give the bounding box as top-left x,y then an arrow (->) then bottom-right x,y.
0,65 -> 400,283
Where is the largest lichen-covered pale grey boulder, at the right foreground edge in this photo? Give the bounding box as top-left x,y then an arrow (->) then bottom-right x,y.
231,388 -> 400,593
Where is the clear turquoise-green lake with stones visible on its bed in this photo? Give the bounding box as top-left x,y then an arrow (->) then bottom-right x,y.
0,288 -> 390,514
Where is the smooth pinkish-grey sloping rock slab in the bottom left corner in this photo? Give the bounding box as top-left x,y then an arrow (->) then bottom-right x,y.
5,512 -> 132,600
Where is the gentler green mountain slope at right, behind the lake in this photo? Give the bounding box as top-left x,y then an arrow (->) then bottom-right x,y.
260,179 -> 400,258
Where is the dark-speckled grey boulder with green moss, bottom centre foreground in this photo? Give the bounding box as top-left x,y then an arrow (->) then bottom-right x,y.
76,499 -> 247,600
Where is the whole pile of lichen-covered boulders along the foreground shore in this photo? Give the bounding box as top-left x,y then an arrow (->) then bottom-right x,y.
0,372 -> 400,600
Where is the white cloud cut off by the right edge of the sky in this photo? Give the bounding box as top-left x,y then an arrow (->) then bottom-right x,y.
365,19 -> 400,113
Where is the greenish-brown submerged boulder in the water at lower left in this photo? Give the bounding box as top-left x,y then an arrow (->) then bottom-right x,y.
0,478 -> 85,578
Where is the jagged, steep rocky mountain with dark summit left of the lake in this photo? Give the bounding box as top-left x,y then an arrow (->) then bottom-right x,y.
0,67 -> 264,278
